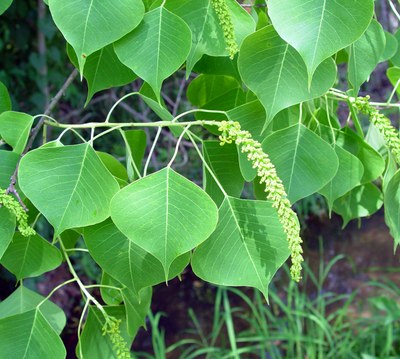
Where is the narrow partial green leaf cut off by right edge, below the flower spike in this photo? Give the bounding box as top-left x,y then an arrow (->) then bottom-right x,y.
384,170 -> 400,248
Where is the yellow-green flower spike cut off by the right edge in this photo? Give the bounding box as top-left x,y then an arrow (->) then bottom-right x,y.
354,96 -> 400,164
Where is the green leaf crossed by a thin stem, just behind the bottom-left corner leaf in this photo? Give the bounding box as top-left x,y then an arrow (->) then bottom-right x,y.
0,286 -> 67,334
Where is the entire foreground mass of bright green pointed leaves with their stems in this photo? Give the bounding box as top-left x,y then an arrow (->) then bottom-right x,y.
0,0 -> 400,358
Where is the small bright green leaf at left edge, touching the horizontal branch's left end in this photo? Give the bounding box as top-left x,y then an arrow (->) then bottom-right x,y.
0,111 -> 33,154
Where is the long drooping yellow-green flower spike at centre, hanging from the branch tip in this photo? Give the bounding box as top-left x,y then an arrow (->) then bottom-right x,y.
219,121 -> 304,282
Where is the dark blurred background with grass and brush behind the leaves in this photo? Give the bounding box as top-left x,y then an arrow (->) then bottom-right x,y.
0,0 -> 400,359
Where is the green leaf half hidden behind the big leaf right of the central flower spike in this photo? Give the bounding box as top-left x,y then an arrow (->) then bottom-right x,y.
319,146 -> 364,209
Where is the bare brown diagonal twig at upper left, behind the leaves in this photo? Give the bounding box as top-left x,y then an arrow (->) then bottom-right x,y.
6,69 -> 78,211
